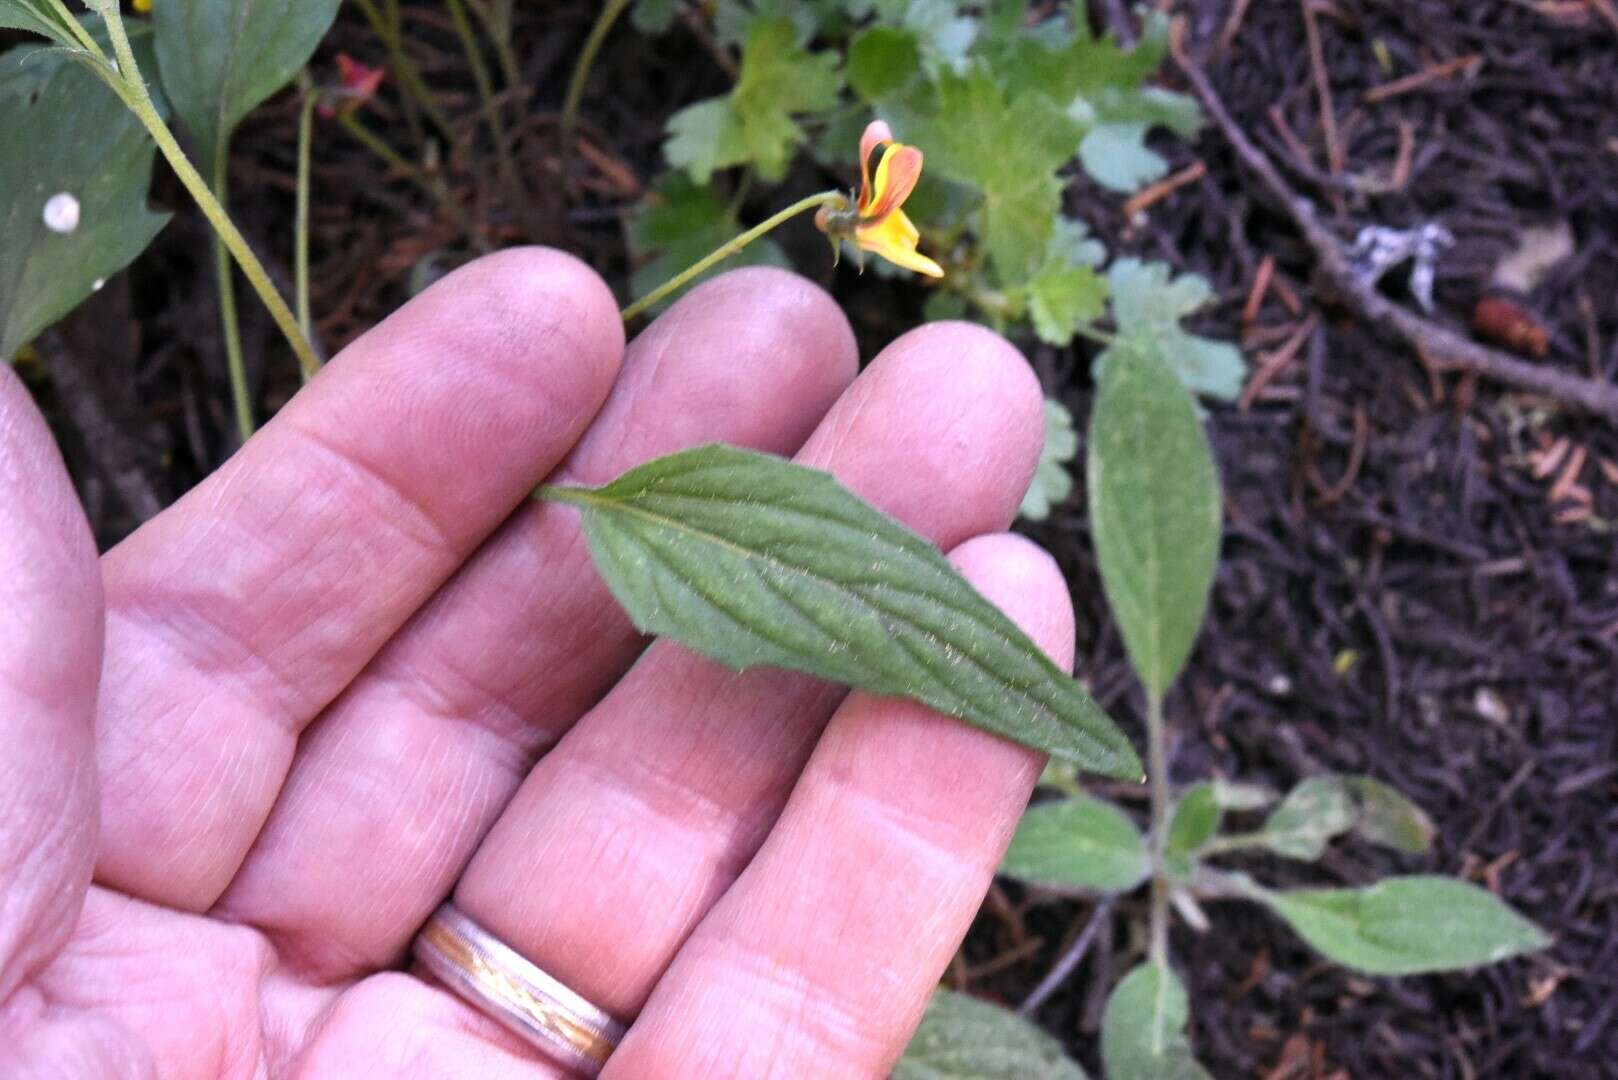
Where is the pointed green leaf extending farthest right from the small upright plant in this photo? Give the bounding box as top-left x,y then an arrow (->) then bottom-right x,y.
1267,874 -> 1550,975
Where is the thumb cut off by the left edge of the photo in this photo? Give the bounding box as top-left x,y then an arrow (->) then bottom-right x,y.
0,364 -> 102,1010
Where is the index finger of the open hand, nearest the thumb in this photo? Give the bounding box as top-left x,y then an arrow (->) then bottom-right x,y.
97,249 -> 623,910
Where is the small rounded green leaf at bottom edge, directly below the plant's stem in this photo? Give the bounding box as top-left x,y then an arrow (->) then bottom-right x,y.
1102,963 -> 1209,1080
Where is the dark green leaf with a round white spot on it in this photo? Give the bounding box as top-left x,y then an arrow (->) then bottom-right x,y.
0,33 -> 168,361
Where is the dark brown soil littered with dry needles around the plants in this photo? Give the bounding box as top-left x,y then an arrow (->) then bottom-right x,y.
15,0 -> 1618,1080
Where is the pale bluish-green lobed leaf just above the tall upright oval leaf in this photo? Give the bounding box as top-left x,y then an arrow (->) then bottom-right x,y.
1107,259 -> 1247,402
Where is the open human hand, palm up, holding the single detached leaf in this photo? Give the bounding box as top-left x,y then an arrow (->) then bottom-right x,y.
0,249 -> 1073,1080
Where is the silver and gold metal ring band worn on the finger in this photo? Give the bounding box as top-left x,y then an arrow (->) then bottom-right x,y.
414,904 -> 625,1077
